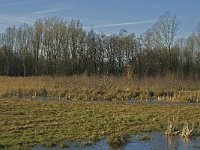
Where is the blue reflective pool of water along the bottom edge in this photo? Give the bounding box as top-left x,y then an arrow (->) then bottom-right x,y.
33,133 -> 200,150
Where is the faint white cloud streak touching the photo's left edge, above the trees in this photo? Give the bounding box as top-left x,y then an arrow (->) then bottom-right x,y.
0,14 -> 34,24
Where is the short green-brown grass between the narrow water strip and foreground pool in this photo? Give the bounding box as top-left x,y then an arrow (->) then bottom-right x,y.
0,99 -> 200,149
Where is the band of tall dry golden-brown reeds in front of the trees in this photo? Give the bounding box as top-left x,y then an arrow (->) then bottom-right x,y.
0,76 -> 200,102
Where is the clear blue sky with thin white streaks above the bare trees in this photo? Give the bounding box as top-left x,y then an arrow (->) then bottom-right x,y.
0,0 -> 200,37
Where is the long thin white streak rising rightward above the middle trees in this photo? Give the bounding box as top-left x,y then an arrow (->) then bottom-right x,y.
84,20 -> 156,28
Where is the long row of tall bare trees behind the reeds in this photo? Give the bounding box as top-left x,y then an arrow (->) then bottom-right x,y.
0,12 -> 200,78
